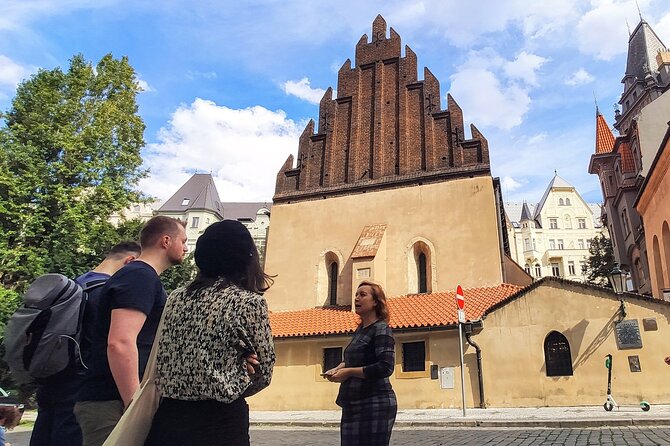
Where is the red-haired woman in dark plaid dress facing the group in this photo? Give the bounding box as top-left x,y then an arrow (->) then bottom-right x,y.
325,282 -> 398,446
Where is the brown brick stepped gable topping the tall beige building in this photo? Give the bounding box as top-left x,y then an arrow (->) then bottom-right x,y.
274,16 -> 490,203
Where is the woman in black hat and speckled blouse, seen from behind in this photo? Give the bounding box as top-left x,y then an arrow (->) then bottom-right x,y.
145,220 -> 275,446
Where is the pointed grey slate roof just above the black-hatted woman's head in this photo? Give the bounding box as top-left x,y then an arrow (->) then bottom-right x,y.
158,173 -> 223,218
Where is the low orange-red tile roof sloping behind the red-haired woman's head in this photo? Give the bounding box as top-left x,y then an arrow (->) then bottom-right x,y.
270,284 -> 521,338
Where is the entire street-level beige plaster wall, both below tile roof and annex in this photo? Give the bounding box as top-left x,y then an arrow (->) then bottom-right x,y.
249,282 -> 670,410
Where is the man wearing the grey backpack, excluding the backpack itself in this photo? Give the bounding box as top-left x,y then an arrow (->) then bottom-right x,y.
30,241 -> 141,446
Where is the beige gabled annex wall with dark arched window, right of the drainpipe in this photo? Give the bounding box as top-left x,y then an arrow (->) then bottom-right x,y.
473,282 -> 670,407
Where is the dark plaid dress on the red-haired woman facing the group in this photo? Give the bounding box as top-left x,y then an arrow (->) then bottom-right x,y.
336,320 -> 398,446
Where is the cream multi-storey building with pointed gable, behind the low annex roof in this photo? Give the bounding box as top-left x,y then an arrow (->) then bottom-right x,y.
505,172 -> 614,281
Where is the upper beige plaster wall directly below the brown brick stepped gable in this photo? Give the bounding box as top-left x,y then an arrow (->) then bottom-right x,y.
265,176 -> 502,311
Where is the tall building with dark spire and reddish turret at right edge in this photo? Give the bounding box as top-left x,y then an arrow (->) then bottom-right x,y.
589,18 -> 670,294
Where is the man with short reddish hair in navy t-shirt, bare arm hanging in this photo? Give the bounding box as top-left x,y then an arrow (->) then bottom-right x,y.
75,216 -> 187,446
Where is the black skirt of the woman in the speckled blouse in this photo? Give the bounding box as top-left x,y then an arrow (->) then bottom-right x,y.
144,398 -> 249,446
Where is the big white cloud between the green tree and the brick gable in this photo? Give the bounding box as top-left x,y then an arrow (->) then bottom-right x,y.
140,99 -> 302,201
